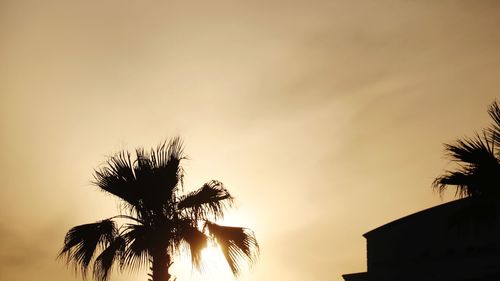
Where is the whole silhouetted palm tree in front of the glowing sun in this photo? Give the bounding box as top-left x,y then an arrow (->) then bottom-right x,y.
59,138 -> 259,281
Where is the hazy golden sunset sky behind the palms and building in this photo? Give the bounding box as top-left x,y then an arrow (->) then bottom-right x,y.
0,0 -> 500,281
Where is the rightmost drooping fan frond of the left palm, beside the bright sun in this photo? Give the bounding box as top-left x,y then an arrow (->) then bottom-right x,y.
205,221 -> 259,276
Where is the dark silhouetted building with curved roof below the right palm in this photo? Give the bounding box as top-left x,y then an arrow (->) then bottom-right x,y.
343,199 -> 500,281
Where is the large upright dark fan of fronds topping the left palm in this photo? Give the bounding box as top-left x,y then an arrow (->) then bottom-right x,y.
93,137 -> 185,215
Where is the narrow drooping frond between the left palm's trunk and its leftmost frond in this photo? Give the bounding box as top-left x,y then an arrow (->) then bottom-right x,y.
93,236 -> 125,281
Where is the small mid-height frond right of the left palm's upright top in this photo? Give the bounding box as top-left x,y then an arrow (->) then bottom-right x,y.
178,180 -> 233,219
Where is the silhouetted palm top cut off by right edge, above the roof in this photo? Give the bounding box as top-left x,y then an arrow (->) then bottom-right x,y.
433,101 -> 500,197
